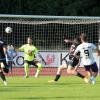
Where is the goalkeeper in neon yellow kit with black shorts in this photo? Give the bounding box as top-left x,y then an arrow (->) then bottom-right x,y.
19,37 -> 42,78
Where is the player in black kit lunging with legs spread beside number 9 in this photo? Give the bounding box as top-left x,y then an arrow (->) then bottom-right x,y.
48,39 -> 88,83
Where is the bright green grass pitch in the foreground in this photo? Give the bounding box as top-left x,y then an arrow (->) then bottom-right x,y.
0,76 -> 100,100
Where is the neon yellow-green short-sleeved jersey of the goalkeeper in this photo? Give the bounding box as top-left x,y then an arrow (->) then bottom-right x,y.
19,44 -> 38,61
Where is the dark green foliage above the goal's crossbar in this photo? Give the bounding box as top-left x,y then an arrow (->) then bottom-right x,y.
0,0 -> 100,16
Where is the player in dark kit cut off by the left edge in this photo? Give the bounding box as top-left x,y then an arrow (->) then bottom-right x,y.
0,41 -> 9,85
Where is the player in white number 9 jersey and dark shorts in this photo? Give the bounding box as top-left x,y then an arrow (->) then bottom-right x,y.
74,34 -> 100,84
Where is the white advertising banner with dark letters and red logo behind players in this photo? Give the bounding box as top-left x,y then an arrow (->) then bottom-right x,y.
13,52 -> 99,67
